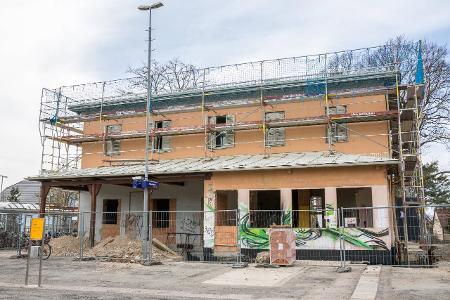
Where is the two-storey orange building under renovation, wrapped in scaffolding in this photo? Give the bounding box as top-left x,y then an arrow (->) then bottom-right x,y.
32,47 -> 424,261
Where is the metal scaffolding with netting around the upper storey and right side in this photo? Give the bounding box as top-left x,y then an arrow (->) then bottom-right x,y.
39,46 -> 426,259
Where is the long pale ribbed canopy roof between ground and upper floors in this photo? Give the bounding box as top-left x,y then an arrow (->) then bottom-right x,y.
29,152 -> 398,181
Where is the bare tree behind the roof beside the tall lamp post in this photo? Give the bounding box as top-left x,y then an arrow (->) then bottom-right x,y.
128,58 -> 201,95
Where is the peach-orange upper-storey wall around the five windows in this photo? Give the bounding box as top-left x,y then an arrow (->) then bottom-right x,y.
82,94 -> 389,168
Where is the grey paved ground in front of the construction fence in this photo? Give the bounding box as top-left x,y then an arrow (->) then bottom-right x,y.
0,251 -> 450,299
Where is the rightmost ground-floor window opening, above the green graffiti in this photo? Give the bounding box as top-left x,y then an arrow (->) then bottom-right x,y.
336,187 -> 373,228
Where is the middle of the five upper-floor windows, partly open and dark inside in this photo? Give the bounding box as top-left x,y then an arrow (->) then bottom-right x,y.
208,115 -> 234,149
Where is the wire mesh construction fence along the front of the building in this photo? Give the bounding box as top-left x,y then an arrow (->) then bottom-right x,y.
0,206 -> 450,266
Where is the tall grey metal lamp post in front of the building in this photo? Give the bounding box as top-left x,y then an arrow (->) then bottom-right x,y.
138,2 -> 163,261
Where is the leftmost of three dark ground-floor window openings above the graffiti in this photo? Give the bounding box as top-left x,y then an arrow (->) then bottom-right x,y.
250,190 -> 282,228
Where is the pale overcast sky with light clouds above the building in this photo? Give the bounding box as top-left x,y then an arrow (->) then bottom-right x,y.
0,0 -> 450,185
